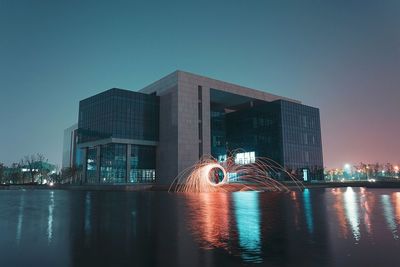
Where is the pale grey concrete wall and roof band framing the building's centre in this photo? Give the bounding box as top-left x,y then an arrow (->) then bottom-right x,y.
139,70 -> 300,184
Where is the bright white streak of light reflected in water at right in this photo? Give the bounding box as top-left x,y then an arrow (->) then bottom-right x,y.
344,187 -> 361,241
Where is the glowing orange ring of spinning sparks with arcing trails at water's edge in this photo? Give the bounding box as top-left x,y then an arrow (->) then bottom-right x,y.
169,153 -> 304,193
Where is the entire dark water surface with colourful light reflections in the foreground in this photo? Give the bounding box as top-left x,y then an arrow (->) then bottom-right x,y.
0,188 -> 400,266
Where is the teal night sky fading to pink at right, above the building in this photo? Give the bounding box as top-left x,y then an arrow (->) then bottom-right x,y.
0,0 -> 400,170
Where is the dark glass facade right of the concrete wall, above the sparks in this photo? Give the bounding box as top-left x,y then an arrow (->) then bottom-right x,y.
210,89 -> 323,180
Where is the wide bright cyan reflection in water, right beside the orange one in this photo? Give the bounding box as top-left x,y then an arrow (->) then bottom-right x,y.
233,191 -> 262,263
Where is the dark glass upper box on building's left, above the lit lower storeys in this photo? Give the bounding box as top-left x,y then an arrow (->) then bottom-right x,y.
78,88 -> 159,143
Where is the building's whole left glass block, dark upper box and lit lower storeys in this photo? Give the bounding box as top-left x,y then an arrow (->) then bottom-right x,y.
78,88 -> 159,184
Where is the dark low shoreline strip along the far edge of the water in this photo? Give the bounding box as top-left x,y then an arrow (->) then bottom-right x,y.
0,181 -> 400,192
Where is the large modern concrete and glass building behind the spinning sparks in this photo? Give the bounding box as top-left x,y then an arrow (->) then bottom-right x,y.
67,71 -> 323,184
